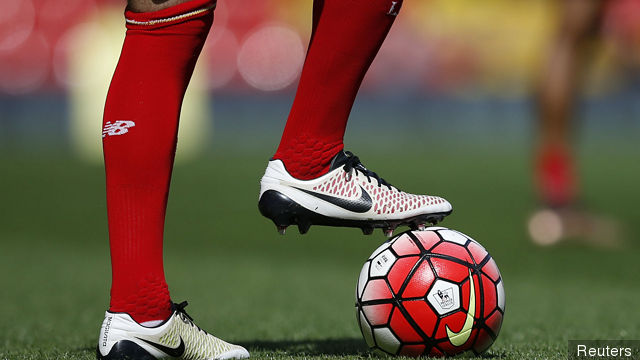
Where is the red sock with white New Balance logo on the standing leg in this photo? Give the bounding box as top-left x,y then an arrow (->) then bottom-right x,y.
102,0 -> 215,322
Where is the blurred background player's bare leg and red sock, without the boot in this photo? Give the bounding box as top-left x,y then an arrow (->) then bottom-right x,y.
536,0 -> 605,207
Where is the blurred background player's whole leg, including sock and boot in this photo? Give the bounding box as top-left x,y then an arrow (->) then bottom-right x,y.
528,0 -> 618,245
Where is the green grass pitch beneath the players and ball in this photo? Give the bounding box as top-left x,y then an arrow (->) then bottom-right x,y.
0,145 -> 640,359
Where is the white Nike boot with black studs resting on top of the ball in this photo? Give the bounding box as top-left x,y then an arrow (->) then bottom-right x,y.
258,151 -> 452,236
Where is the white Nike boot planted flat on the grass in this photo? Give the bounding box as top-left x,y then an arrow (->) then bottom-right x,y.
96,301 -> 249,360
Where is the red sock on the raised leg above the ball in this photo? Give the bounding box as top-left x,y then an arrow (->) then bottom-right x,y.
274,0 -> 402,180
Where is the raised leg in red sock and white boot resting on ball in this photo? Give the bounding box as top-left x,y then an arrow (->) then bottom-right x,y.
259,0 -> 451,238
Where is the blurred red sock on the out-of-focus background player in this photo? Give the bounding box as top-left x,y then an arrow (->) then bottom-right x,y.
536,146 -> 577,207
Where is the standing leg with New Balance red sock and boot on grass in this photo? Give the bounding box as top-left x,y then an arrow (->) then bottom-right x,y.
97,0 -> 248,359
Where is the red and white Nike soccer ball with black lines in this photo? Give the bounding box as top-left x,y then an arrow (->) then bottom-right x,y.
356,227 -> 504,356
